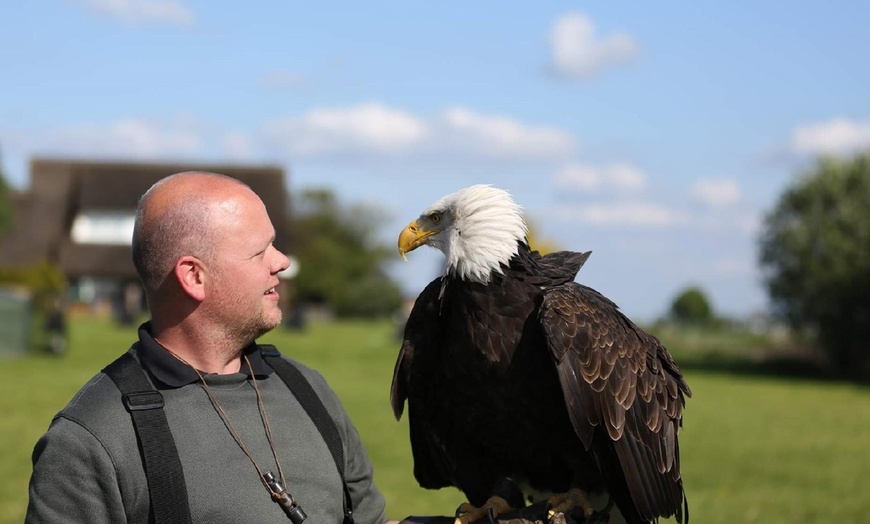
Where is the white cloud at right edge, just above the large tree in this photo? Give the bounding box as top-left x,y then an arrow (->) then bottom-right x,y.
791,118 -> 870,155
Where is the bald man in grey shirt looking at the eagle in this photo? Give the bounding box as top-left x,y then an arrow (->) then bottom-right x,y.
26,172 -> 386,524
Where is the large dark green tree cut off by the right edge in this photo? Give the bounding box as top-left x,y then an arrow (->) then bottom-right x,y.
760,151 -> 870,378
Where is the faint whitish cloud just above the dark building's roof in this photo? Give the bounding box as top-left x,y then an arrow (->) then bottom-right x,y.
42,119 -> 203,158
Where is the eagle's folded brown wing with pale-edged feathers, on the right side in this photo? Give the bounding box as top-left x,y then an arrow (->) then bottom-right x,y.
540,283 -> 691,521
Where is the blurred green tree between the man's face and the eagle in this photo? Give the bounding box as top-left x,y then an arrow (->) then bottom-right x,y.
292,189 -> 402,317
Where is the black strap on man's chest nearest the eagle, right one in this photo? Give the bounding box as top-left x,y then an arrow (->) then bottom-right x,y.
260,344 -> 353,524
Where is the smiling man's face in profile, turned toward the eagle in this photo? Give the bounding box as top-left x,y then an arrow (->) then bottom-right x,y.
207,192 -> 290,344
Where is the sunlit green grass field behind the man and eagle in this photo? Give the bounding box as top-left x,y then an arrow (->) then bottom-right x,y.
0,319 -> 870,524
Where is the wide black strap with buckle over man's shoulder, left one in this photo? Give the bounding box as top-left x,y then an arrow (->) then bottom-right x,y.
103,353 -> 191,524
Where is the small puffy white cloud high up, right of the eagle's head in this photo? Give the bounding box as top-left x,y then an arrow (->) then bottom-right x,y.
550,13 -> 640,78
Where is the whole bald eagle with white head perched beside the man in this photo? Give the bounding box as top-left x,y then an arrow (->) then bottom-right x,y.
390,185 -> 691,523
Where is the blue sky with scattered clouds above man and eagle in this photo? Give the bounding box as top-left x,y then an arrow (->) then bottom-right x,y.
0,0 -> 870,321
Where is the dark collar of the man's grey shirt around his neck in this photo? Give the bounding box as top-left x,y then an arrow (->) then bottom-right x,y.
137,322 -> 273,388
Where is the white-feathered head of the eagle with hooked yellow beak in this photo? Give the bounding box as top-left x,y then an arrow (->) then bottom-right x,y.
399,184 -> 528,284
